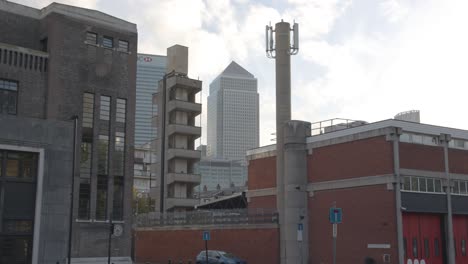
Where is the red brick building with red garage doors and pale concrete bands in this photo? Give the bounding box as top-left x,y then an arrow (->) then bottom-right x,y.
247,119 -> 468,264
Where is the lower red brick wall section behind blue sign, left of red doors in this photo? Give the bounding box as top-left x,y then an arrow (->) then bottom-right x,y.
309,185 -> 398,264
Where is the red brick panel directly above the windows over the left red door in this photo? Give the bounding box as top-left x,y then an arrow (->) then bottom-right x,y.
400,143 -> 445,171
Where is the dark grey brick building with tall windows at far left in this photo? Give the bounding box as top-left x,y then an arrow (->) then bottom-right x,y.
0,1 -> 137,264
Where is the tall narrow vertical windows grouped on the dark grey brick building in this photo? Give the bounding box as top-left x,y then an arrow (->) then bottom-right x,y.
78,93 -> 126,220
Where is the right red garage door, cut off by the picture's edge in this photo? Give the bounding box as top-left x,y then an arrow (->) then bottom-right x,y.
453,215 -> 468,264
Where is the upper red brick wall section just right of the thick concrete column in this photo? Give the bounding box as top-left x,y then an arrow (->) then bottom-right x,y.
308,136 -> 393,182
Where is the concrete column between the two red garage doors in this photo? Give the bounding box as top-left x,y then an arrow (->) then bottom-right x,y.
439,134 -> 455,264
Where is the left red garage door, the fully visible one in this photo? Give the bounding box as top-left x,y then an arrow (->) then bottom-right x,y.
403,213 -> 442,264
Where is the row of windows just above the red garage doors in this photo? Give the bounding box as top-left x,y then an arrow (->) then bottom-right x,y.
401,176 -> 468,195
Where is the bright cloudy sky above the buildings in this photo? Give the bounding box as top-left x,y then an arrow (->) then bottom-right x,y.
13,0 -> 468,145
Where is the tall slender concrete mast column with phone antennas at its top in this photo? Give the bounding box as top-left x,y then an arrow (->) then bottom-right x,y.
275,22 -> 291,263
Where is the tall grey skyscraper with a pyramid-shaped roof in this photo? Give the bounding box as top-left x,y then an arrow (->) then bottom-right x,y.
207,61 -> 259,160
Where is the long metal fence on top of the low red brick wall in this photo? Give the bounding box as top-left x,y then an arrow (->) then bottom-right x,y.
133,208 -> 278,227
